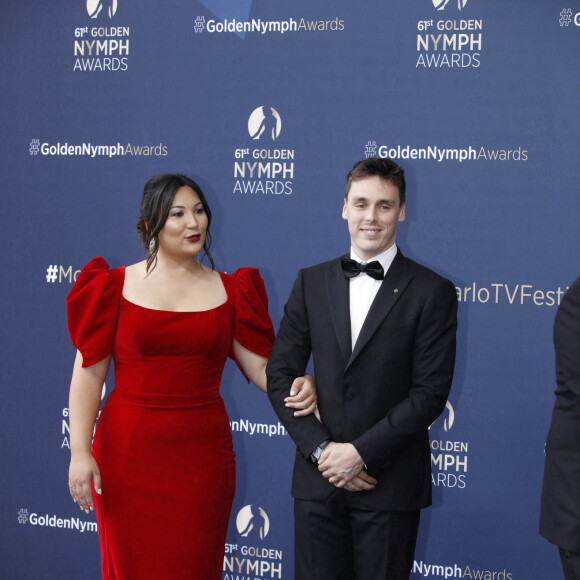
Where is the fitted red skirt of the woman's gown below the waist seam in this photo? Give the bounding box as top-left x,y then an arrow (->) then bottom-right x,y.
93,389 -> 235,580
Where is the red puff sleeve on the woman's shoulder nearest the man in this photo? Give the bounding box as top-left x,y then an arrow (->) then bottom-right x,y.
230,268 -> 274,379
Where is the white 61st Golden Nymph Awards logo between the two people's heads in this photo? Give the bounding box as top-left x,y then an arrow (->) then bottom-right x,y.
233,105 -> 294,195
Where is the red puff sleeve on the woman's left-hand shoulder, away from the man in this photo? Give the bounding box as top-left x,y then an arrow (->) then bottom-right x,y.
66,257 -> 123,367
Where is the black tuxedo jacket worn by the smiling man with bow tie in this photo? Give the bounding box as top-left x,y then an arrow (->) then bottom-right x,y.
267,250 -> 457,510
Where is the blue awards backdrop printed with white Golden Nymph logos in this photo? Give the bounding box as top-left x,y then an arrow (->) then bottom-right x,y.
0,0 -> 580,580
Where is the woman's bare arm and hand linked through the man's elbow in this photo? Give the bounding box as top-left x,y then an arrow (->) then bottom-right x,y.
234,340 -> 317,417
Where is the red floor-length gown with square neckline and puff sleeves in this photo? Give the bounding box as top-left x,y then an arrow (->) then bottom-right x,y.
67,258 -> 274,580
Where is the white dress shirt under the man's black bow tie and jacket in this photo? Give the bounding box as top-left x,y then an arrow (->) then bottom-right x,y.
349,244 -> 397,350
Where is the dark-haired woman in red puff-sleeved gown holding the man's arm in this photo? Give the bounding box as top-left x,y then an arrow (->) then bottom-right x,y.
67,174 -> 316,580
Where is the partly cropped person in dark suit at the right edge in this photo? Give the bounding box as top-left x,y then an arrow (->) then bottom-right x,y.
540,278 -> 580,580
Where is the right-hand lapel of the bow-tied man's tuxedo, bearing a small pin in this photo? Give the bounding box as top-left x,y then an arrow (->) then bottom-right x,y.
345,250 -> 412,371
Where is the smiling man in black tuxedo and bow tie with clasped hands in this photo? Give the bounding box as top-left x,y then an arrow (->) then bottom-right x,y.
267,158 -> 457,580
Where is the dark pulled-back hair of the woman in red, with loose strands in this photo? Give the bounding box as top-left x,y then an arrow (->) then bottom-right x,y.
137,173 -> 215,272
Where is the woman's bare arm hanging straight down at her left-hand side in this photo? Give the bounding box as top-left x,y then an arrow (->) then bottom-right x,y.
68,351 -> 111,513
